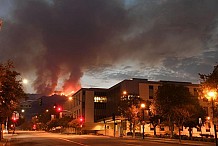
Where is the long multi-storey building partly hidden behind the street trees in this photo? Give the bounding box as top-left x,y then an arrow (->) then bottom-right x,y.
67,78 -> 218,136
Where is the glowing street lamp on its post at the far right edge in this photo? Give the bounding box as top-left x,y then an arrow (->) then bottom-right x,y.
206,90 -> 218,146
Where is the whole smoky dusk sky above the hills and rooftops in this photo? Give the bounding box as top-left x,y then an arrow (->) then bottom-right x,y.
0,0 -> 218,94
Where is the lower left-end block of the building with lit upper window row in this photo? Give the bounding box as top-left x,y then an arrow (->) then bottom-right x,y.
64,88 -> 107,133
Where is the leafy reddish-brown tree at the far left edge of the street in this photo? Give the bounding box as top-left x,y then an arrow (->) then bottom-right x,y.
0,61 -> 26,140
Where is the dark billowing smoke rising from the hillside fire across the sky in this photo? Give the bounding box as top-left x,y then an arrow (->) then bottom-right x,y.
0,0 -> 218,94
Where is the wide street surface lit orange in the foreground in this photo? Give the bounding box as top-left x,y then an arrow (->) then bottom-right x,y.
8,131 -> 214,146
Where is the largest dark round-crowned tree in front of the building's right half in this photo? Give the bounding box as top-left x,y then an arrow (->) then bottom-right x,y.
155,84 -> 193,137
